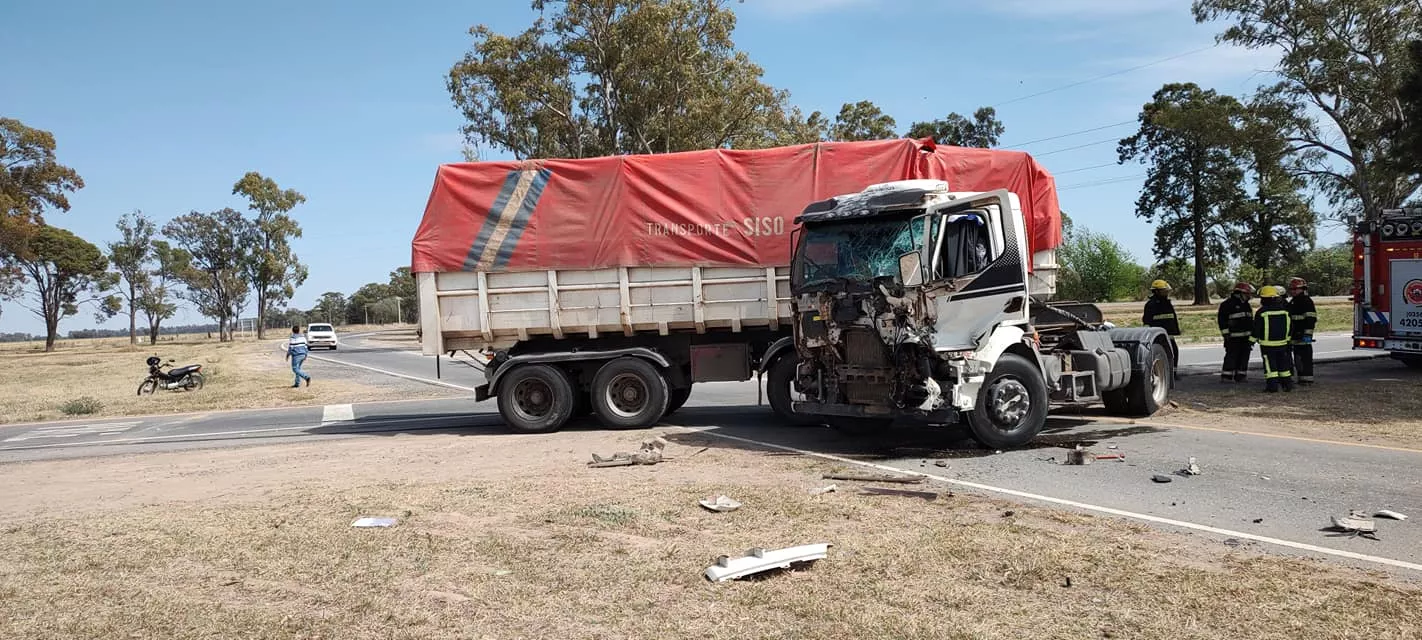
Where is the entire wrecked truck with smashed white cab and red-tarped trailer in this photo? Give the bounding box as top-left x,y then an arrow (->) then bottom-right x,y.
411,139 -> 1173,448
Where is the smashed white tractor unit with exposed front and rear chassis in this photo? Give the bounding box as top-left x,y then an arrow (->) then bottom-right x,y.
772,181 -> 1172,447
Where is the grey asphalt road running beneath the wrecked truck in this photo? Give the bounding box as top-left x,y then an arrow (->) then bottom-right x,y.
0,329 -> 1422,576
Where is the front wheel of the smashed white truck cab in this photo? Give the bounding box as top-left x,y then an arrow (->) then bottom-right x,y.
967,353 -> 1048,449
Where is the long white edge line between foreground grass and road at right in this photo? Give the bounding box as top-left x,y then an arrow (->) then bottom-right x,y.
667,425 -> 1422,572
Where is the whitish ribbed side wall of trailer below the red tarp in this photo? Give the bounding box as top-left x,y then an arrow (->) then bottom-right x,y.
417,266 -> 791,356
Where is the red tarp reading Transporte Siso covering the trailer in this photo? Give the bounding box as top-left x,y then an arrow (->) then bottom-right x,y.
411,139 -> 1061,273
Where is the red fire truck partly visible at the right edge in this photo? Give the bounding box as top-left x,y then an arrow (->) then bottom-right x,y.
1352,208 -> 1422,368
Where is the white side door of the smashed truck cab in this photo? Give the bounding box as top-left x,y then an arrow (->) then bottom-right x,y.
926,191 -> 1031,351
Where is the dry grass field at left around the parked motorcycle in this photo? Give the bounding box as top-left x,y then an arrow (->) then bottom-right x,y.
0,336 -> 445,422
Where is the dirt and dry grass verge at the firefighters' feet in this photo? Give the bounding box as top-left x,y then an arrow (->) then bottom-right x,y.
1167,362 -> 1422,449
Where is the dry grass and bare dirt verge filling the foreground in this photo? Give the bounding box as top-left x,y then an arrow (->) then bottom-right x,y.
0,432 -> 1422,640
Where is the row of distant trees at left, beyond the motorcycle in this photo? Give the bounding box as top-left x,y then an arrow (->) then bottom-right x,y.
0,118 -> 307,351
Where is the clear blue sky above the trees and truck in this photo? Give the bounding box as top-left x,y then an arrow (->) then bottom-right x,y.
0,0 -> 1337,333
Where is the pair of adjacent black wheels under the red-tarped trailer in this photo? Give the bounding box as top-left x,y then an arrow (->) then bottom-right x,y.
498,357 -> 671,434
